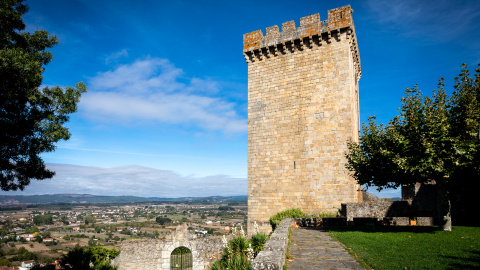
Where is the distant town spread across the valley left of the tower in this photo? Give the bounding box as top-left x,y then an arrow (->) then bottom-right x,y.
0,194 -> 247,269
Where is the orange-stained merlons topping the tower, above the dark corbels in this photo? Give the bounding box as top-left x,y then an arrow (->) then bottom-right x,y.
243,5 -> 361,77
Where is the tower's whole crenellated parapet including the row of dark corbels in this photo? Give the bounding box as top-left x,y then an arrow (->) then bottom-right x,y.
243,5 -> 361,78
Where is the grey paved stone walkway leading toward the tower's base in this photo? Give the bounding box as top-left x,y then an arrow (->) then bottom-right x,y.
288,227 -> 365,270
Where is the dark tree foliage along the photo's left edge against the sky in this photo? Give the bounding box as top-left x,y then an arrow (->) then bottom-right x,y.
0,0 -> 86,191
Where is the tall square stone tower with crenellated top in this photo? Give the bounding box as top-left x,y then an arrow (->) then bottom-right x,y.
243,6 -> 361,232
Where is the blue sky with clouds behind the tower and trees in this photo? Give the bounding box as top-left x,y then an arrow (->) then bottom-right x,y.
2,0 -> 480,197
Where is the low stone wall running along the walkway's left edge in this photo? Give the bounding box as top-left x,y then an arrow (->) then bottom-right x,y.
252,218 -> 295,270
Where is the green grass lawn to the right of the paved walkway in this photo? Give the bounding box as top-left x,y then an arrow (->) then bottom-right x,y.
327,226 -> 480,270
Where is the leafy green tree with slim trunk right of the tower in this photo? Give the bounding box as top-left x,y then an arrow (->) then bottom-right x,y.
346,64 -> 480,230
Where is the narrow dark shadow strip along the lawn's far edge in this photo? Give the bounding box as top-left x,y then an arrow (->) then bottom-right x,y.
322,226 -> 440,233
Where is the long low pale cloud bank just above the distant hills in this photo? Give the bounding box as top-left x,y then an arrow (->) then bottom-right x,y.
4,163 -> 247,198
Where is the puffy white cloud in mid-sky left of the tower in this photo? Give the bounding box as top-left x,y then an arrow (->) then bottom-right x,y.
80,58 -> 247,133
